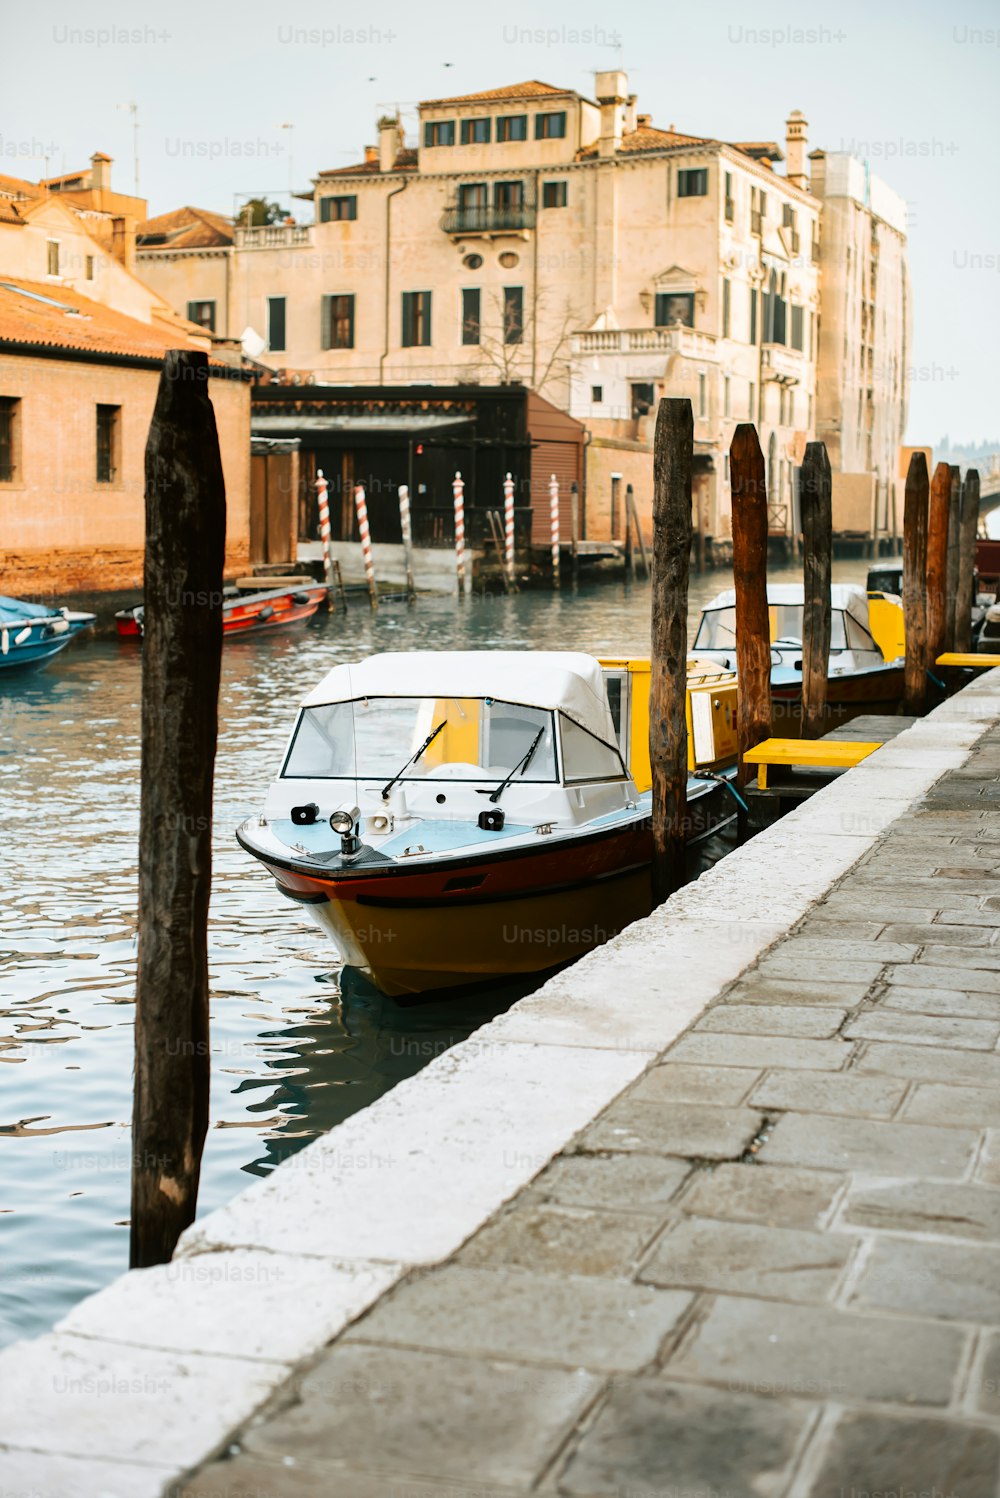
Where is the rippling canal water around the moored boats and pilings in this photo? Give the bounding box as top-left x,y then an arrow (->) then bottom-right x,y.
0,562 -> 864,1344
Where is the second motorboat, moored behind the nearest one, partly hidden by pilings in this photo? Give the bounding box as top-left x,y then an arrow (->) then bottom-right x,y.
695,583 -> 904,737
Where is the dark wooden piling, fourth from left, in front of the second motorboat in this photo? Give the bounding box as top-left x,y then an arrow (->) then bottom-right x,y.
799,442 -> 834,739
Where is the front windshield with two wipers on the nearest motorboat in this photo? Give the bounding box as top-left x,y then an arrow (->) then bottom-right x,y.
281,697 -> 555,786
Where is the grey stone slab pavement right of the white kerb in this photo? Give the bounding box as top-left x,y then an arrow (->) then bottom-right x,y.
175,727 -> 1000,1498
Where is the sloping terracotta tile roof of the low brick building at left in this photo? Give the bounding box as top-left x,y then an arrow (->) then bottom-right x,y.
0,276 -> 211,360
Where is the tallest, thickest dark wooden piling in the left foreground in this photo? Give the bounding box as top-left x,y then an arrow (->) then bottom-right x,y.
129,349 -> 226,1267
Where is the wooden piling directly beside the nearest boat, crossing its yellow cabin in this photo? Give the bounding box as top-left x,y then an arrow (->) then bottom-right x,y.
652,400 -> 695,905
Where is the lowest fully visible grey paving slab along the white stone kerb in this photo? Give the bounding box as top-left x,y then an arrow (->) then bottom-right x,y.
243,1344 -> 600,1494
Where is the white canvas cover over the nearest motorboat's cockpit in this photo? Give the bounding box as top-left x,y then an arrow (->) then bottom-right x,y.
302,650 -> 617,745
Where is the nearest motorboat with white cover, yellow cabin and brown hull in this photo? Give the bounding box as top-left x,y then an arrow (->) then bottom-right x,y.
237,650 -> 735,996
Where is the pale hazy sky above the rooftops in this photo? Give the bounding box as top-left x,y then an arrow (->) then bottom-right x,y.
0,0 -> 1000,445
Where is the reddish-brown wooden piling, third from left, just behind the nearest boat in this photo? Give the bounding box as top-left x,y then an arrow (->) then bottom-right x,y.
729,421 -> 771,785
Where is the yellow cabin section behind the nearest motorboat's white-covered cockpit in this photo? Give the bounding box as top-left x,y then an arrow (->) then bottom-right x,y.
600,656 -> 737,791
